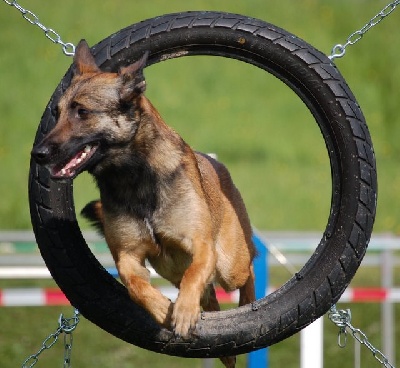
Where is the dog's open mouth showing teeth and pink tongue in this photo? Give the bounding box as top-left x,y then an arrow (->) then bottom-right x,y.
50,144 -> 98,179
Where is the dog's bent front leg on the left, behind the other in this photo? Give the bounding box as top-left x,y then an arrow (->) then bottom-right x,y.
116,253 -> 173,328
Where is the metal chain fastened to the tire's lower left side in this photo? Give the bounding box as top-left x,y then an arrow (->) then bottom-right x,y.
21,309 -> 80,368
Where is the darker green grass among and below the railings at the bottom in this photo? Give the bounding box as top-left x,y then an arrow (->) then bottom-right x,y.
0,267 -> 400,368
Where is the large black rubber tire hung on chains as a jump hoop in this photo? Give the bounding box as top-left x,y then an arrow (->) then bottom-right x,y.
29,12 -> 377,357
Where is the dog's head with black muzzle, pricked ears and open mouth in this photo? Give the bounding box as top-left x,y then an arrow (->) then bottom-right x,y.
32,40 -> 148,180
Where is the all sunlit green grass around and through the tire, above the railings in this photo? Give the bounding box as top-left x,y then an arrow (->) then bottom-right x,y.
0,0 -> 400,233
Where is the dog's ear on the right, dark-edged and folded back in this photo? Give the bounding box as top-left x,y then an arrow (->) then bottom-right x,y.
118,51 -> 149,103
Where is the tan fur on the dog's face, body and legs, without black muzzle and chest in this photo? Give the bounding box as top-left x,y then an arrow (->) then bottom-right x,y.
32,40 -> 255,367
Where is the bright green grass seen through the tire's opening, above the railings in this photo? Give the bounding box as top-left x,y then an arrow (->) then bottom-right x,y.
75,57 -> 330,229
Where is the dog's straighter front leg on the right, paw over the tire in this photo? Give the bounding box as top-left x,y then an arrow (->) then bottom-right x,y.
172,239 -> 216,336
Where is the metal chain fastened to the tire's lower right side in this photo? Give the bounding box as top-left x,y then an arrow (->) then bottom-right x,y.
328,305 -> 394,368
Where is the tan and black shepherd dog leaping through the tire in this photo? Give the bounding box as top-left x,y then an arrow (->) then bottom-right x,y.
32,40 -> 256,367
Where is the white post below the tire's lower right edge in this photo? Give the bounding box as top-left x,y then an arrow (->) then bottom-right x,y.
300,317 -> 323,368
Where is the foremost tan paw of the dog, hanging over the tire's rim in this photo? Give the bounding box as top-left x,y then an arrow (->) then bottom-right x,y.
171,297 -> 200,337
